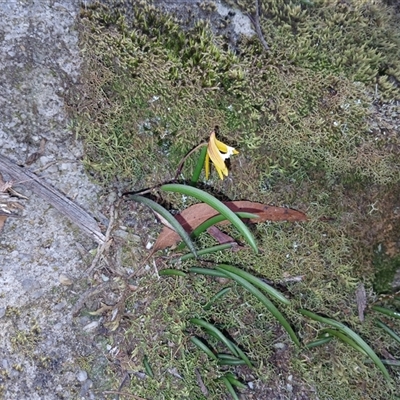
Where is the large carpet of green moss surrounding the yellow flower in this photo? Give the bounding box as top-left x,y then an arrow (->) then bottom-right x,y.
71,0 -> 400,399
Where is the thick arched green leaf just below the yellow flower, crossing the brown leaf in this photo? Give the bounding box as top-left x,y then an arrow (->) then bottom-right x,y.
161,183 -> 258,253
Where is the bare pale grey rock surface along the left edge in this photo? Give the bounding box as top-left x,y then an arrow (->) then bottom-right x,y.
0,0 -> 104,400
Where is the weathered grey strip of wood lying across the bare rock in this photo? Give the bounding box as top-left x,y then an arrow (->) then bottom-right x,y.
0,154 -> 105,244
